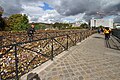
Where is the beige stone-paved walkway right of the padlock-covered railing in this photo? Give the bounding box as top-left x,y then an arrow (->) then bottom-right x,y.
39,34 -> 120,80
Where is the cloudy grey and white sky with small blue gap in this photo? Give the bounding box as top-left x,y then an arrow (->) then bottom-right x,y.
0,0 -> 120,23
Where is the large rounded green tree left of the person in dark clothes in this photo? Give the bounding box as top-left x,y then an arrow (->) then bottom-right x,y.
8,14 -> 29,31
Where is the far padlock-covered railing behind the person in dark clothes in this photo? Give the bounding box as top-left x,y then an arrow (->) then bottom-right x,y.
0,30 -> 88,45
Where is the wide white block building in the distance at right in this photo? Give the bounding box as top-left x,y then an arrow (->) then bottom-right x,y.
90,19 -> 114,28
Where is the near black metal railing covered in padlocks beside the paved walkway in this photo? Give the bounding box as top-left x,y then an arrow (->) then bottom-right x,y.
0,30 -> 96,80
